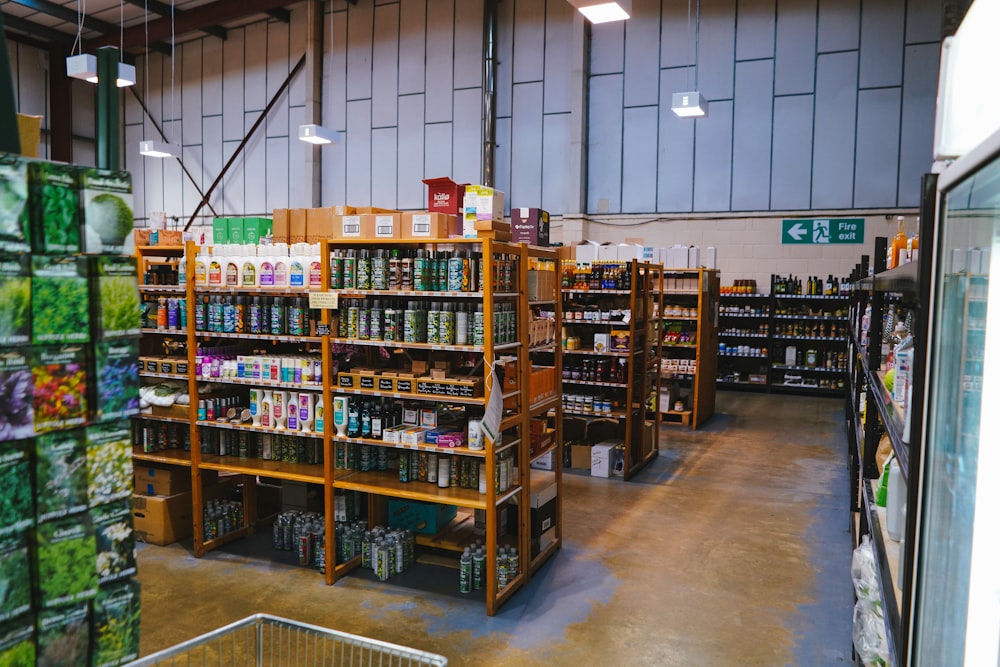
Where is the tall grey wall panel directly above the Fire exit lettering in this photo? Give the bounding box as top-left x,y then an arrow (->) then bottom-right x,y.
812,51 -> 858,208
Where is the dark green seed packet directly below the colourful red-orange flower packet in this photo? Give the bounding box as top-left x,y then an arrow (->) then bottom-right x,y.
35,428 -> 87,523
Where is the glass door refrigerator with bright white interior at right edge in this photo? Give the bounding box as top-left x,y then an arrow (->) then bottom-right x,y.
904,132 -> 1000,667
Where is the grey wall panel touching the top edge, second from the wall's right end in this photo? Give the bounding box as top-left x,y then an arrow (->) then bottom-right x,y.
858,0 -> 905,88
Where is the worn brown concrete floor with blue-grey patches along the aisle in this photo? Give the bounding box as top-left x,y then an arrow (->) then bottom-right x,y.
139,392 -> 853,667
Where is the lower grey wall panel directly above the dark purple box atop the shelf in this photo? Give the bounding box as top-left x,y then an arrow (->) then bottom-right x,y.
510,83 -> 544,211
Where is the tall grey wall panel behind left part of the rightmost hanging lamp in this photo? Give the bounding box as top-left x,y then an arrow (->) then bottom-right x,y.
656,69 -> 696,212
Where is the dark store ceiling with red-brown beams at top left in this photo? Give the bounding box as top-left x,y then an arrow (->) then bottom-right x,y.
0,0 -> 306,54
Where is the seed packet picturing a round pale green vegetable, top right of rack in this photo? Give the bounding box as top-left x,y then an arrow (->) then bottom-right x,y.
80,169 -> 135,255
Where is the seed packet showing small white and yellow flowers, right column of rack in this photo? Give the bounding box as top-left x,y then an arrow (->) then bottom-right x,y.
86,420 -> 132,507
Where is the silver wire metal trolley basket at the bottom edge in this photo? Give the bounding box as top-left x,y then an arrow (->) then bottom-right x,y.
127,614 -> 448,667
